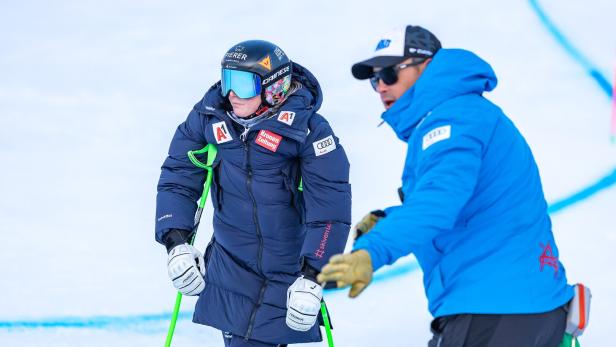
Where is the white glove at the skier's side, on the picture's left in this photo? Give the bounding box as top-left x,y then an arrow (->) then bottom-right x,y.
167,243 -> 205,295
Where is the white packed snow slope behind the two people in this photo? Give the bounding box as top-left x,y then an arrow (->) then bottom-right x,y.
0,0 -> 616,347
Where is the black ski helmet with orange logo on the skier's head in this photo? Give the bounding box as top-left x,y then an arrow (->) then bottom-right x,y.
221,40 -> 291,106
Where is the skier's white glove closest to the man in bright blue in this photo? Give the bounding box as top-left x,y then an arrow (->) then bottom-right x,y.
287,276 -> 323,331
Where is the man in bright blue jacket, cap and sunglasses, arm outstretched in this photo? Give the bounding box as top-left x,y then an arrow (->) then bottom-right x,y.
318,26 -> 573,347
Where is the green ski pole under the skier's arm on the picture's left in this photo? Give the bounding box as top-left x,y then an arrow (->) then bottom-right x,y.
165,144 -> 218,347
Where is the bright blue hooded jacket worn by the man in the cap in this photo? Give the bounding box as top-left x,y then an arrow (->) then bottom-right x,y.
354,49 -> 573,317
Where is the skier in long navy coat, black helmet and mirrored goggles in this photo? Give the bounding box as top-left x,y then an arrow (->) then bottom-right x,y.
156,40 -> 351,347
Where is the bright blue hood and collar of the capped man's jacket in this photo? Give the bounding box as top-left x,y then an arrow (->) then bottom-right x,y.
381,49 -> 497,142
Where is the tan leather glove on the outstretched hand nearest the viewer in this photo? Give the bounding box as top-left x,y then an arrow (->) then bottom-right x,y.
317,249 -> 373,298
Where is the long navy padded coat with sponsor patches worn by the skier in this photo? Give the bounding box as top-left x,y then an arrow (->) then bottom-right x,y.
156,63 -> 351,344
